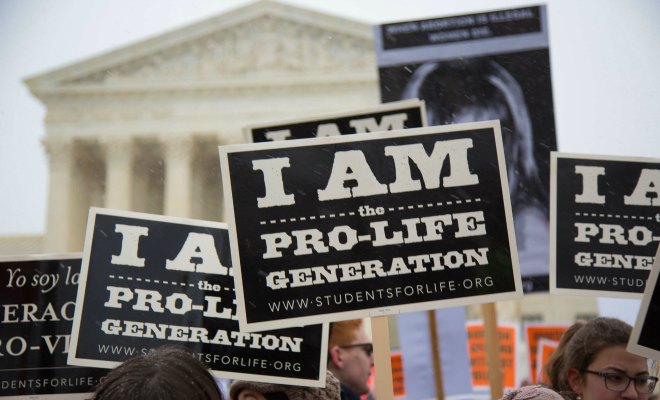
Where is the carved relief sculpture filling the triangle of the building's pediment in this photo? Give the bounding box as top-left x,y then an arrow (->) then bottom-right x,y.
65,15 -> 374,85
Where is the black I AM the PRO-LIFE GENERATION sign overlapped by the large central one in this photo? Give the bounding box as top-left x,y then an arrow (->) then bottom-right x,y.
69,208 -> 327,386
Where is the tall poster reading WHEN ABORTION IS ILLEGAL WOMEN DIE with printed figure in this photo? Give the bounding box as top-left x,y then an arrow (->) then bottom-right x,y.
374,6 -> 557,292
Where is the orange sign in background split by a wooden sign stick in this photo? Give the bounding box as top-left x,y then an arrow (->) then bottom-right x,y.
466,322 -> 518,390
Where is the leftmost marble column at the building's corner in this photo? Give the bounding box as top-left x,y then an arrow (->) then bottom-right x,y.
43,138 -> 76,253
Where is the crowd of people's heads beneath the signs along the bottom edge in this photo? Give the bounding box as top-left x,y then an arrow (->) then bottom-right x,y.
87,317 -> 658,400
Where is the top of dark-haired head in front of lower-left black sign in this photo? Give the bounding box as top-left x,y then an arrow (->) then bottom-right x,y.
92,346 -> 222,400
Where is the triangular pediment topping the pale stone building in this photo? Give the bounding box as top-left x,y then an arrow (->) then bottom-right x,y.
27,1 -> 375,94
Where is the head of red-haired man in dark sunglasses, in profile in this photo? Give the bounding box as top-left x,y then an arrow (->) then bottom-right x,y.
328,319 -> 374,399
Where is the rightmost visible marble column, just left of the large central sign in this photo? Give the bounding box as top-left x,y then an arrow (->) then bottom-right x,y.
161,136 -> 193,217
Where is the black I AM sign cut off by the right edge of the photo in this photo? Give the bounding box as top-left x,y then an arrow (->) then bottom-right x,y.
550,152 -> 660,298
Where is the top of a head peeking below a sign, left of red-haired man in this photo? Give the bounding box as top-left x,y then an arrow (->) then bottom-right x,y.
229,371 -> 340,400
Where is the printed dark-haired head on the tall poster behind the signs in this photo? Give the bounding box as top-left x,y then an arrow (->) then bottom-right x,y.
402,59 -> 548,215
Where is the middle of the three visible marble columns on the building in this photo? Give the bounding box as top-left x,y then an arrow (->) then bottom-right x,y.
101,137 -> 134,210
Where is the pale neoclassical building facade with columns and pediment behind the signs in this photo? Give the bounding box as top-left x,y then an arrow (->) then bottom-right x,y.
26,1 -> 379,252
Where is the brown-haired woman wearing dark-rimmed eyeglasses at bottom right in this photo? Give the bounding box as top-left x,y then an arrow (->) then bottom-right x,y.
545,317 -> 658,400
